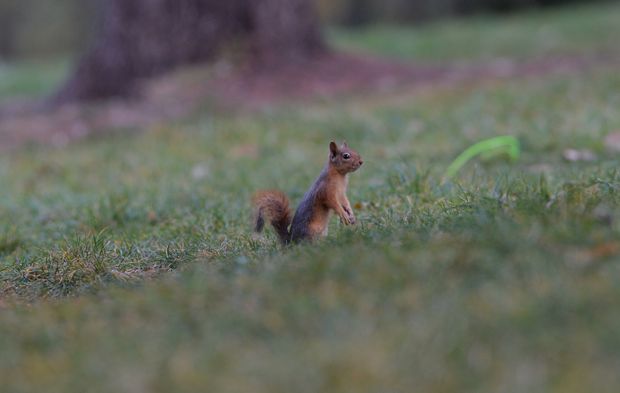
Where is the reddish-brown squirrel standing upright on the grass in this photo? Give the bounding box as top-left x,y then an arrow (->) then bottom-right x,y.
253,141 -> 364,245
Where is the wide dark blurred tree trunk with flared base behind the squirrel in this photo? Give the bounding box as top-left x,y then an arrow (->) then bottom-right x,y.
55,0 -> 325,102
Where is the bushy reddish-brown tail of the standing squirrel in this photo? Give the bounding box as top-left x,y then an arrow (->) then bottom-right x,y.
252,191 -> 291,244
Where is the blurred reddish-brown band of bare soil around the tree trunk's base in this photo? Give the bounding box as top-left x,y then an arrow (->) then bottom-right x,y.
0,54 -> 620,151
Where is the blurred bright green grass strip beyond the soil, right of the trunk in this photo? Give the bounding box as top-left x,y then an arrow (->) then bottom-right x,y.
330,2 -> 620,62
